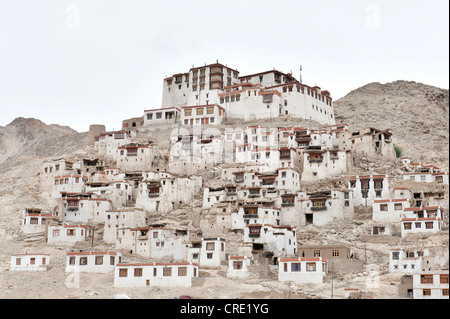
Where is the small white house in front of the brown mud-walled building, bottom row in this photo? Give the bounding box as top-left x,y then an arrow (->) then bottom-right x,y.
278,257 -> 328,284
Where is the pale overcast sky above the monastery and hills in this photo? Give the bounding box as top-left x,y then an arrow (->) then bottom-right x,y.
0,0 -> 449,132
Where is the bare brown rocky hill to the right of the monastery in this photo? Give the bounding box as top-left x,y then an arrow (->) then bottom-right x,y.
334,81 -> 449,167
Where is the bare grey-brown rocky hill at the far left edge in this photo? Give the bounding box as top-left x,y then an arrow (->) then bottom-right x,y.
0,117 -> 87,172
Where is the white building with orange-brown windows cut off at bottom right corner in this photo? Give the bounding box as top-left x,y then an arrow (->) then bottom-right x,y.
413,269 -> 449,299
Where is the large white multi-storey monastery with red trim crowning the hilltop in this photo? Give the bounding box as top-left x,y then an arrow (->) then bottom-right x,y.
144,63 -> 335,126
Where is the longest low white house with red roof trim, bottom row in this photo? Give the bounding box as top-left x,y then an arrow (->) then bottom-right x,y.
114,263 -> 198,287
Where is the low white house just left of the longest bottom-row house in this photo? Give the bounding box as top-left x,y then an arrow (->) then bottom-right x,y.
66,251 -> 122,273
